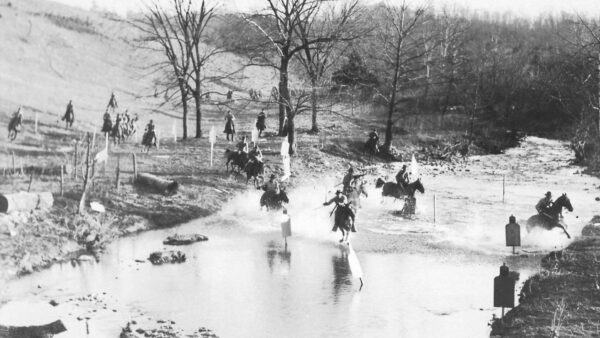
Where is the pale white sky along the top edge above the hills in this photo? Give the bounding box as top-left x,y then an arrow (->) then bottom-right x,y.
53,0 -> 600,17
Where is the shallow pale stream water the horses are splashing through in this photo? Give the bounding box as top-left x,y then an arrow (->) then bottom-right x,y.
0,138 -> 599,337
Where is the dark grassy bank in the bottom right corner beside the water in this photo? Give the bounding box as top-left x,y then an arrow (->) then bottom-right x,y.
491,216 -> 600,337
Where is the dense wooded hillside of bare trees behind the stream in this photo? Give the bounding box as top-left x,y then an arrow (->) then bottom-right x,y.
145,0 -> 600,160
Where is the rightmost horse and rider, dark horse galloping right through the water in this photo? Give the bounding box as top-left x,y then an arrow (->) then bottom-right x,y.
527,191 -> 573,238
